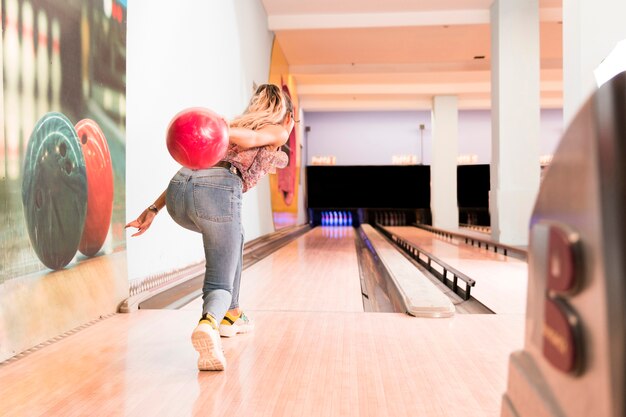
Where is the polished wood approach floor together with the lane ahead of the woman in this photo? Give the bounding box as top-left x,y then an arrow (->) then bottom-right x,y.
0,228 -> 524,417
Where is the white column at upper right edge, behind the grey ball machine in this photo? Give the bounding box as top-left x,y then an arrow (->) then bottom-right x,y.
563,0 -> 626,126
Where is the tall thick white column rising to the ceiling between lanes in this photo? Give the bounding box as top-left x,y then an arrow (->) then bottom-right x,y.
489,0 -> 540,245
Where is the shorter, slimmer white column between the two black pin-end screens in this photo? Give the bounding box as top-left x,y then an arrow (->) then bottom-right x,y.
430,96 -> 459,229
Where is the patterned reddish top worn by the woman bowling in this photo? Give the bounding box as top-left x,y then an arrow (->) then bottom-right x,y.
224,144 -> 289,193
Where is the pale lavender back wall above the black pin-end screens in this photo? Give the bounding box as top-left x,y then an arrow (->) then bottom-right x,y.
303,109 -> 563,165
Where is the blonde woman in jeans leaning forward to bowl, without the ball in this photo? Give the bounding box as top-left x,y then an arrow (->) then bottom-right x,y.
126,84 -> 294,370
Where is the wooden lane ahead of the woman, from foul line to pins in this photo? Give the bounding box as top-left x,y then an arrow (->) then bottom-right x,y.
184,226 -> 363,312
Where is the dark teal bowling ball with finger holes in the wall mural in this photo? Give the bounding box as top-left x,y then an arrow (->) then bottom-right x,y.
22,113 -> 87,269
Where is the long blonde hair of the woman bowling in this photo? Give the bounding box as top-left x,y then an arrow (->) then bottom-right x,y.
230,84 -> 293,130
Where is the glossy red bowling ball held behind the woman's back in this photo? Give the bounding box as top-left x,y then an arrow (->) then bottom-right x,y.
167,107 -> 228,169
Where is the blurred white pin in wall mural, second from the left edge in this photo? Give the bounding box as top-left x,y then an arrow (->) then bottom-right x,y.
20,1 -> 37,154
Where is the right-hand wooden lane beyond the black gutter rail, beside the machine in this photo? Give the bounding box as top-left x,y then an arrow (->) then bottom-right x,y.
386,227 -> 528,314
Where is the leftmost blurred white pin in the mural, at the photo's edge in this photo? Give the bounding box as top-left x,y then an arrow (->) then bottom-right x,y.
3,0 -> 21,179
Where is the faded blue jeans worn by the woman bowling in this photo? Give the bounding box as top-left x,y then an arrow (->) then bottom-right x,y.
166,168 -> 244,323
